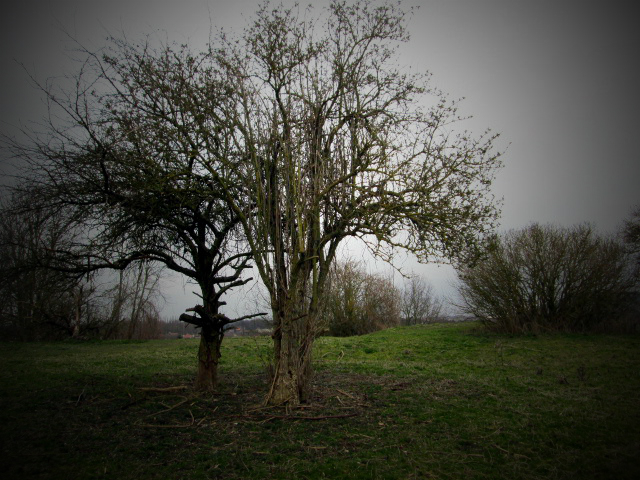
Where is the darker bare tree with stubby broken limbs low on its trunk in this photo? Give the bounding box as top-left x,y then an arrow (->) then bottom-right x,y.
3,39 -> 262,389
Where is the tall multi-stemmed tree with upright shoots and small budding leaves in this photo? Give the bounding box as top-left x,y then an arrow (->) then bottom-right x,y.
202,1 -> 500,405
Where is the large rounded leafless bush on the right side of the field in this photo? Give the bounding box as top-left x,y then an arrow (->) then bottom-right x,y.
458,224 -> 633,333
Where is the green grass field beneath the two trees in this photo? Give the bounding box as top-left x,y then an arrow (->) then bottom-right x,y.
0,324 -> 640,480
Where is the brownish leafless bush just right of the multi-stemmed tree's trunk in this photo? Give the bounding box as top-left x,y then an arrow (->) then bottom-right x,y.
322,261 -> 401,337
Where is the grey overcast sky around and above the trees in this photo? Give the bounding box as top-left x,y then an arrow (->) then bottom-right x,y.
0,0 -> 640,314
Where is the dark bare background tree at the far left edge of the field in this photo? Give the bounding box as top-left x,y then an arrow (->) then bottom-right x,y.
0,196 -> 115,340
